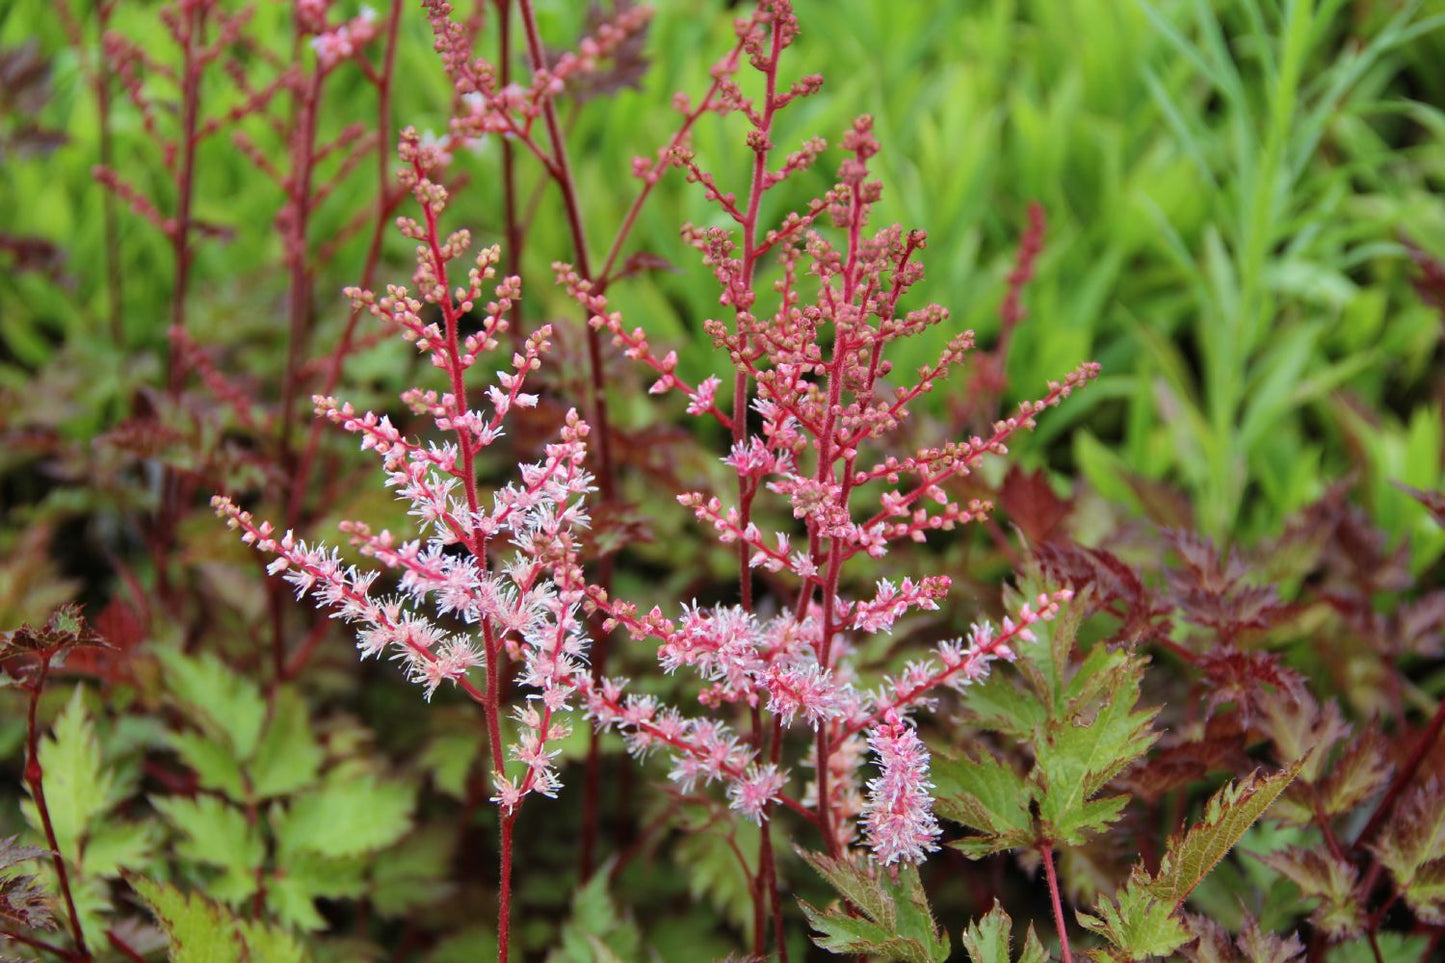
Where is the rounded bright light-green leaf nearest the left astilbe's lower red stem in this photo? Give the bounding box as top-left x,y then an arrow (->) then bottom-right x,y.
276,774 -> 416,856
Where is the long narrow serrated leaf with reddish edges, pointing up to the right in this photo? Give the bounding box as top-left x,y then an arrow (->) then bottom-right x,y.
1149,762 -> 1301,910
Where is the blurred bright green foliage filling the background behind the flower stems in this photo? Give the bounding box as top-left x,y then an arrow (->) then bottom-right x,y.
0,0 -> 1445,555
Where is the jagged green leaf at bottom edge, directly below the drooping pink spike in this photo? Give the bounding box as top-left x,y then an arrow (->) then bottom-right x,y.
798,850 -> 949,963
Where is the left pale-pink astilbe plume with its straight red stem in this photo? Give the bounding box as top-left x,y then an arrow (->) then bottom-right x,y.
214,130 -> 591,959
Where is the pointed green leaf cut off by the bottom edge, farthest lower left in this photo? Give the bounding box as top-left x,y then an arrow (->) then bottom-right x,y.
126,875 -> 309,963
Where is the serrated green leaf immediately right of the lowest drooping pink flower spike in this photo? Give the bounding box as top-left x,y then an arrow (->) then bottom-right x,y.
932,750 -> 1035,859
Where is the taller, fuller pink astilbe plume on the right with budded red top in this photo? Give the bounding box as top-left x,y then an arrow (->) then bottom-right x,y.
558,0 -> 1098,953
